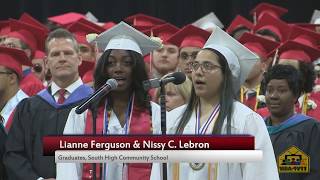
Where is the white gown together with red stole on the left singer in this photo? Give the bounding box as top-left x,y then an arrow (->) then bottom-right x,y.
79,102 -> 161,180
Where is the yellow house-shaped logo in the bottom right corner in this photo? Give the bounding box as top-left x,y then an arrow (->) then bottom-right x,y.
278,146 -> 310,173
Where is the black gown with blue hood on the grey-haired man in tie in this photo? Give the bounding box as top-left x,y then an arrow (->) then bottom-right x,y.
4,85 -> 92,180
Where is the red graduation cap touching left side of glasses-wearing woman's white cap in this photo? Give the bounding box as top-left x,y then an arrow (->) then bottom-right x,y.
167,24 -> 210,48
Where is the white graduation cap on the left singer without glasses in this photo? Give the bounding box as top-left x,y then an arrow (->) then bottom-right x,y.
93,22 -> 161,56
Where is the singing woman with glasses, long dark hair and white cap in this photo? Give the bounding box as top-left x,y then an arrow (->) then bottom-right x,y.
154,27 -> 278,180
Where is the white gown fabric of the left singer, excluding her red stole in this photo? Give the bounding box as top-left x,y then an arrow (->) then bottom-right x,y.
56,102 -> 161,180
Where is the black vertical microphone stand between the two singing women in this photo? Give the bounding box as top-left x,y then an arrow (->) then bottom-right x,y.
160,81 -> 168,180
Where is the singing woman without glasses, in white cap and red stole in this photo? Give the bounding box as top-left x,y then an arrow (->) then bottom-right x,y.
63,22 -> 161,180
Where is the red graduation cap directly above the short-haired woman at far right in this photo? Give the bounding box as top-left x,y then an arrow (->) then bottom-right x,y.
272,41 -> 320,63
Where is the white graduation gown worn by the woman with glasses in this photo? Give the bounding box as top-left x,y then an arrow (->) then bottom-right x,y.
151,102 -> 279,180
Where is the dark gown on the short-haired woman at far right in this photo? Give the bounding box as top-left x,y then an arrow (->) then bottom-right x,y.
267,118 -> 320,180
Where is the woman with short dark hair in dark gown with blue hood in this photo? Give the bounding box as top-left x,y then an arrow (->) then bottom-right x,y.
265,64 -> 320,180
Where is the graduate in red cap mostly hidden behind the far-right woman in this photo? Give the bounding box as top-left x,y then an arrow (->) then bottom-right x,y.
258,40 -> 320,120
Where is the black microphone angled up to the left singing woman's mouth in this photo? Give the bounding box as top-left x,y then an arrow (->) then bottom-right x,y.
76,79 -> 118,114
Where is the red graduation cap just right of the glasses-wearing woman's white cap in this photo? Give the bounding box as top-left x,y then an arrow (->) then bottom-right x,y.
239,32 -> 280,60
